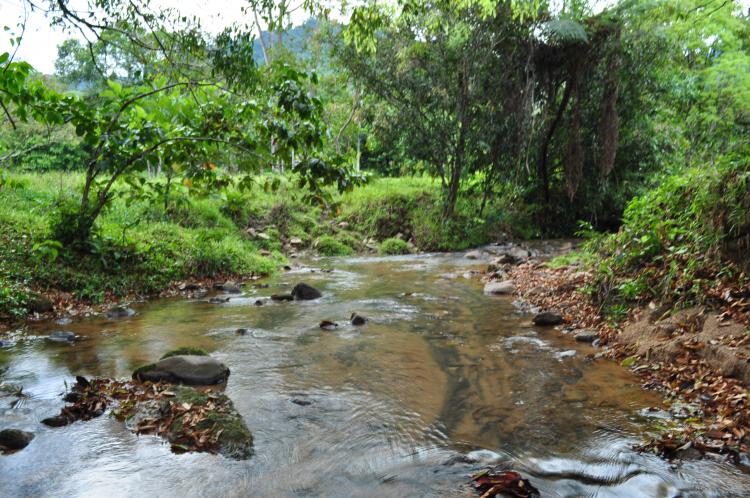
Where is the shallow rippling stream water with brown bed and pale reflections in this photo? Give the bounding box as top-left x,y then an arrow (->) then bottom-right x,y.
0,255 -> 750,497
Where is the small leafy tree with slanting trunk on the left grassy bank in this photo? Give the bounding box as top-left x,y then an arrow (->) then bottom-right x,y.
0,0 -> 360,248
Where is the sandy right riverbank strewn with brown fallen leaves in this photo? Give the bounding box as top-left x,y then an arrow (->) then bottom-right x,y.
490,261 -> 750,466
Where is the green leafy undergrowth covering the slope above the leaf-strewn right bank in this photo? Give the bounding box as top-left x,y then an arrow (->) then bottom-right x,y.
589,158 -> 750,304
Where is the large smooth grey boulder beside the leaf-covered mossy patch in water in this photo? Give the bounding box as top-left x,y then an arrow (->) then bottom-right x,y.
133,355 -> 229,386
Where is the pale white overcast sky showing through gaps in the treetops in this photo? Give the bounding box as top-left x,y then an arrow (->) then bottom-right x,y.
0,0 -> 750,74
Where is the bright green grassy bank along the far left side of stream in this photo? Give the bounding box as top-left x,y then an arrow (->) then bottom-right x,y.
0,172 -> 512,319
